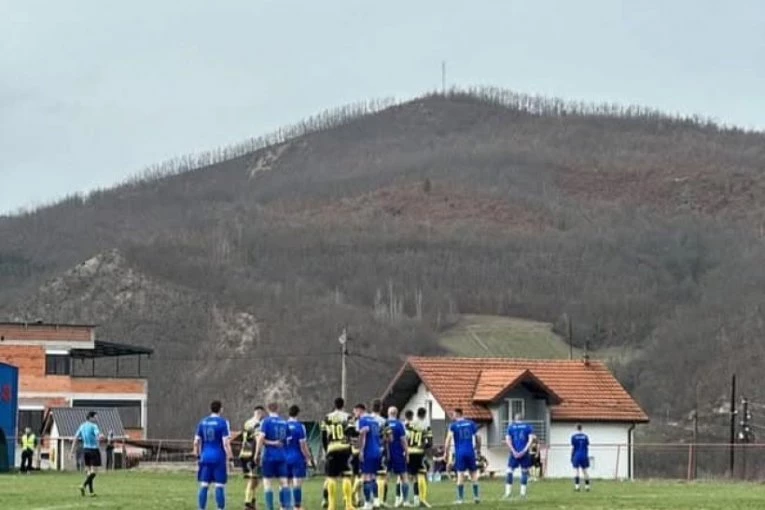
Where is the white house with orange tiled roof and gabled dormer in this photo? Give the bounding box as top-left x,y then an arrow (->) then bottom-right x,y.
385,357 -> 648,479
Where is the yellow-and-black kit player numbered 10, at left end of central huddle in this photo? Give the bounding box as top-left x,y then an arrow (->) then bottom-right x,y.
321,398 -> 355,510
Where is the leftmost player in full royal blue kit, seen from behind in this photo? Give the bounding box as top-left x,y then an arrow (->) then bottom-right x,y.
194,400 -> 234,510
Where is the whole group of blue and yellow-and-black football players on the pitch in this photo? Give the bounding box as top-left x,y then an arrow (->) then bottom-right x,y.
194,398 -> 590,510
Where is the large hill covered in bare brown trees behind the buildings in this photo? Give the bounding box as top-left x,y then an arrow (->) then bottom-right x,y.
0,89 -> 765,437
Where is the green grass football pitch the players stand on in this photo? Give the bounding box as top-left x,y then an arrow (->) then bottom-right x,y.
0,472 -> 765,510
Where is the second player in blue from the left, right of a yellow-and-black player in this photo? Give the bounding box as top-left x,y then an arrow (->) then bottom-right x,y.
255,402 -> 292,510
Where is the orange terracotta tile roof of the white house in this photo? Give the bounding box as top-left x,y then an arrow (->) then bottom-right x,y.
407,357 -> 648,422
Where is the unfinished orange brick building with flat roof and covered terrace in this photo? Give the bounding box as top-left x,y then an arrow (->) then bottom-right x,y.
0,322 -> 152,446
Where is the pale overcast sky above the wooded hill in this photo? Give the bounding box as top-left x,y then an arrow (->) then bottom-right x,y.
0,0 -> 765,213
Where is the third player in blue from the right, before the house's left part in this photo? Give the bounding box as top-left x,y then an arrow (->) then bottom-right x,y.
444,408 -> 481,504
